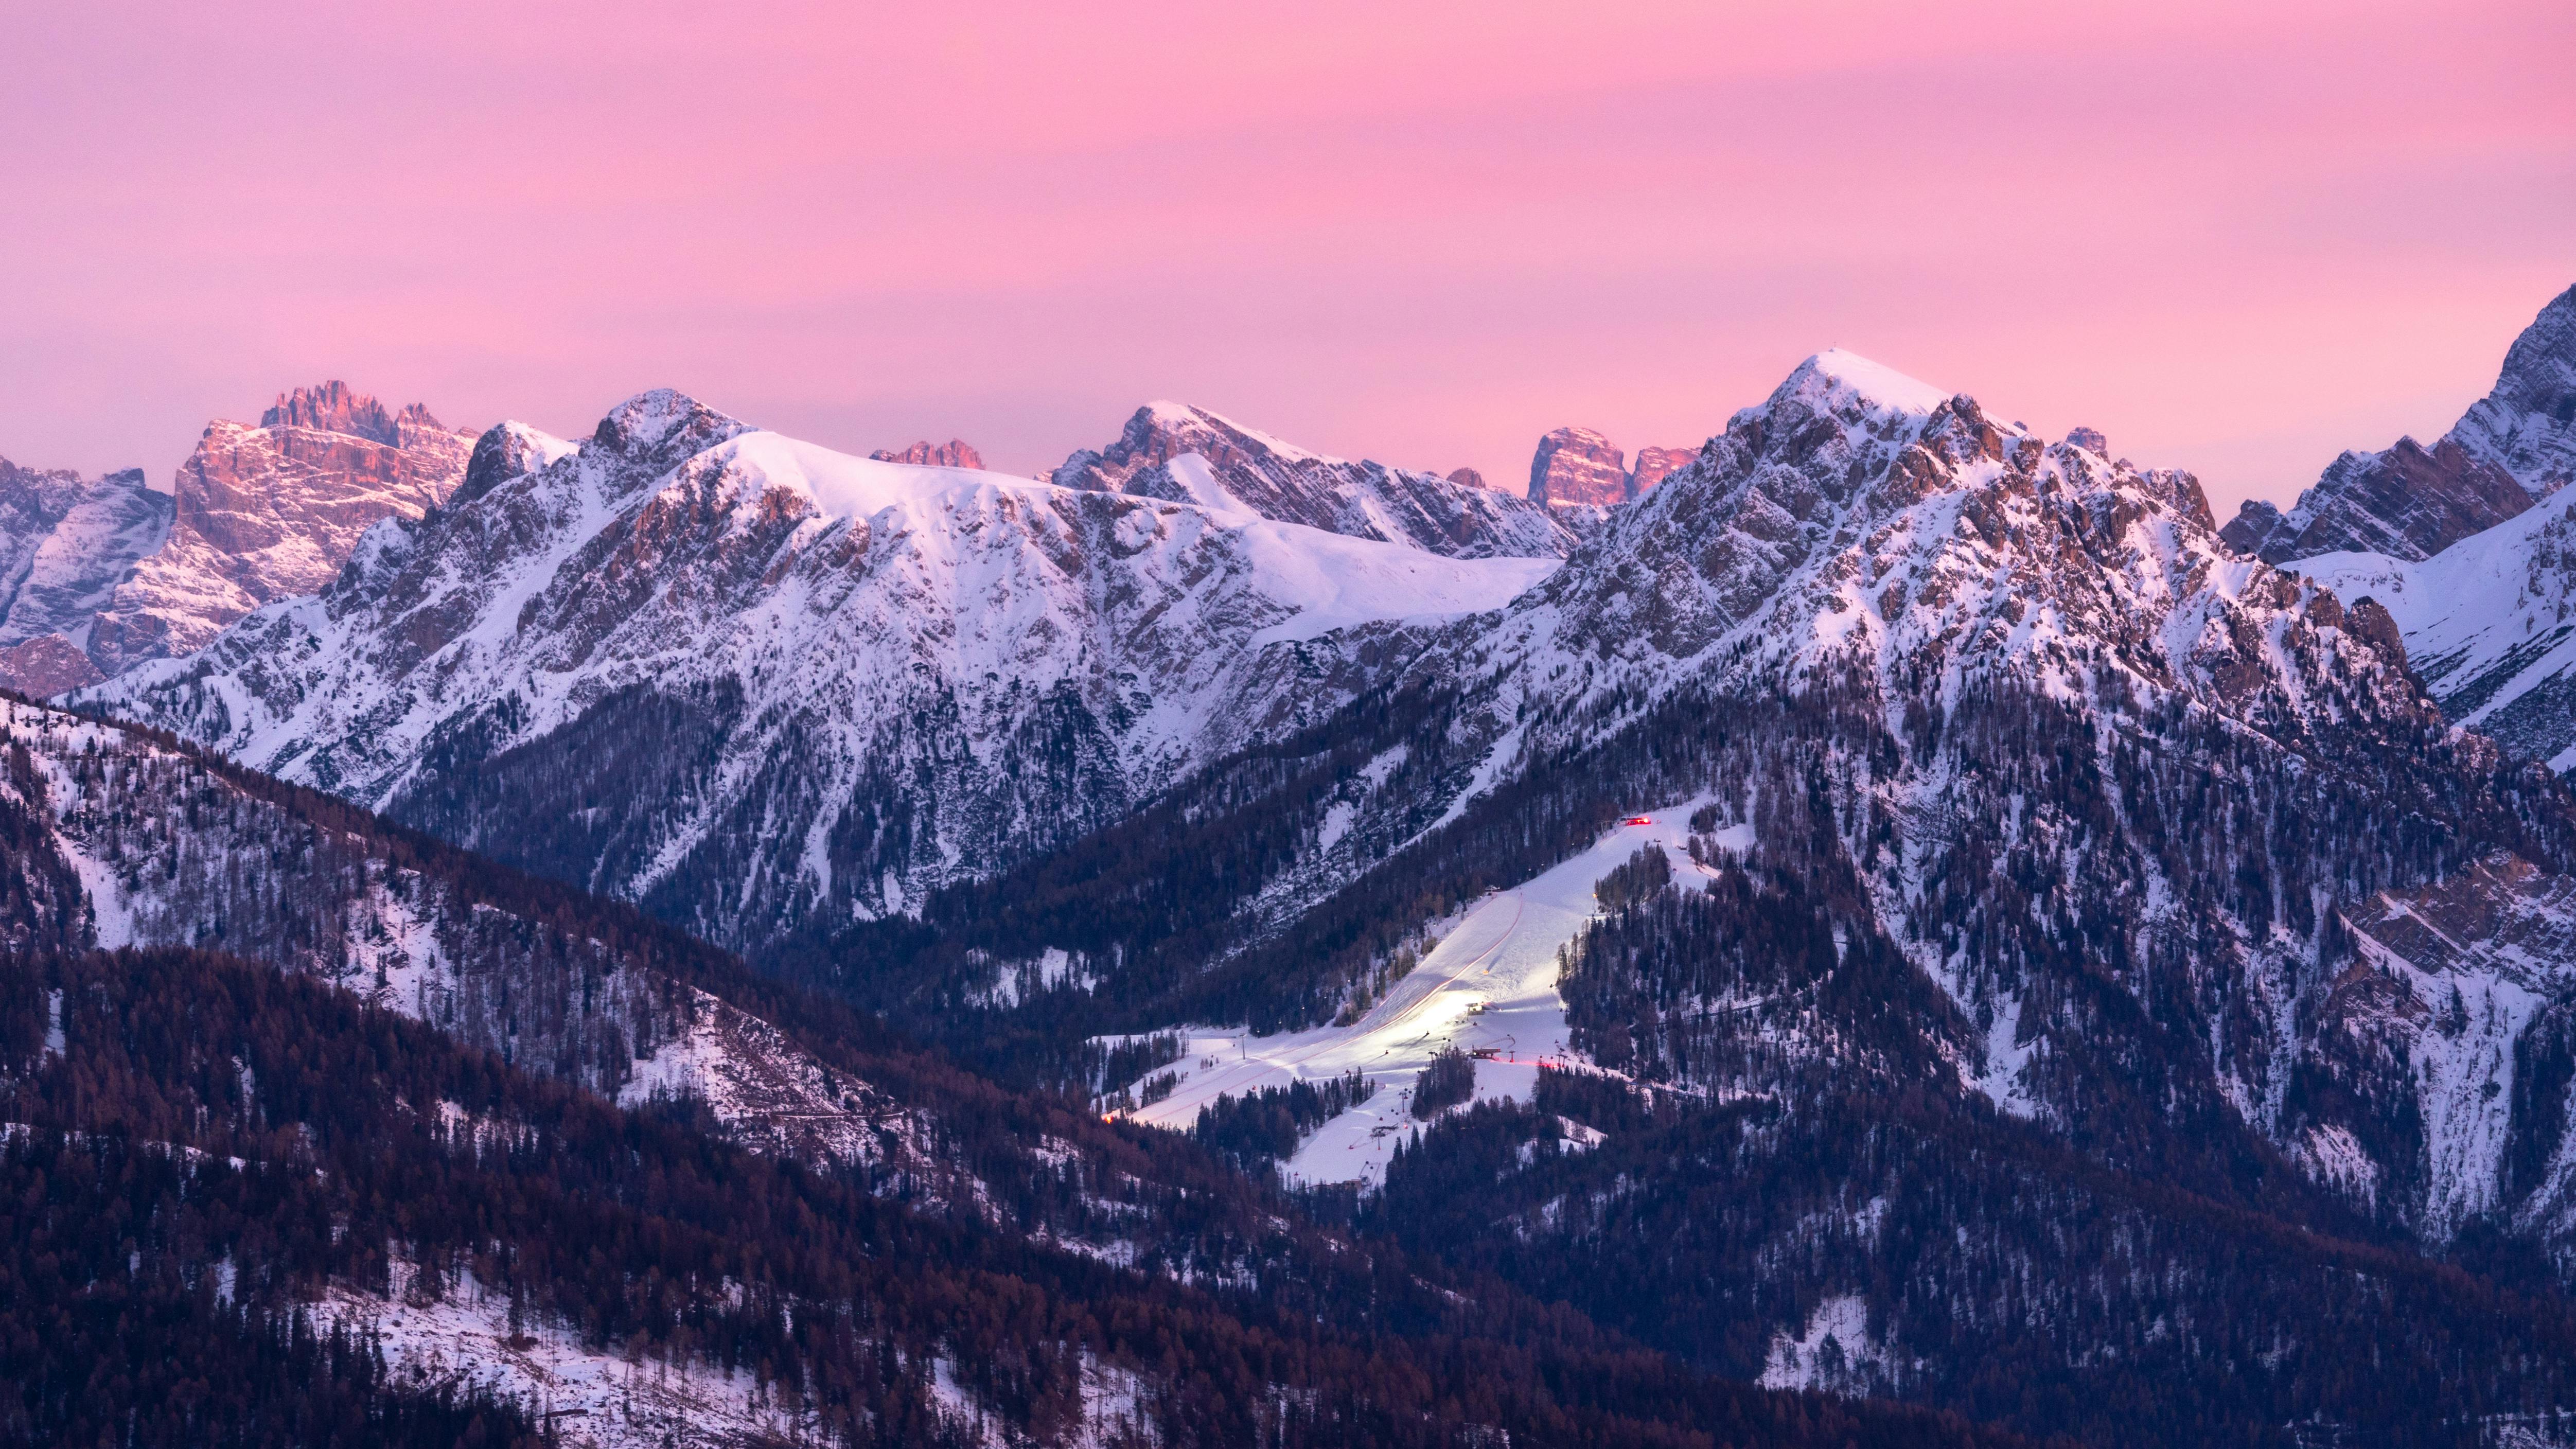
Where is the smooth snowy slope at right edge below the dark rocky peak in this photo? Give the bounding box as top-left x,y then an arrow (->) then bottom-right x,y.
2298,489 -> 2576,770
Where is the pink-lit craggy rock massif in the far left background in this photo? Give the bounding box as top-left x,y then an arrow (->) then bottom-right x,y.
87,381 -> 474,674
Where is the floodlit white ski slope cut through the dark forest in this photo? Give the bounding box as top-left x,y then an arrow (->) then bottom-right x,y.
1134,803 -> 1752,1184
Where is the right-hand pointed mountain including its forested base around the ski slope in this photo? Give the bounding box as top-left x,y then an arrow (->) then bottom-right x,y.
788,352 -> 2576,1444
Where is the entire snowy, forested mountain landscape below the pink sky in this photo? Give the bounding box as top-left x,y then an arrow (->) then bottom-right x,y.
15,288 -> 2576,1446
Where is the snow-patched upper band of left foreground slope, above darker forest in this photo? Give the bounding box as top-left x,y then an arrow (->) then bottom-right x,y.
0,700 -> 920,1166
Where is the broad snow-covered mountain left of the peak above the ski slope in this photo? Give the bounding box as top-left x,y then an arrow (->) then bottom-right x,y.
82,391 -> 1561,942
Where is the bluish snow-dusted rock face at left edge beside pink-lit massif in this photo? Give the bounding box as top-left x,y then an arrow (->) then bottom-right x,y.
0,458 -> 172,695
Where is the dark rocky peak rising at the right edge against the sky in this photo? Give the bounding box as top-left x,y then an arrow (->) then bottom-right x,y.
2223,288 -> 2576,563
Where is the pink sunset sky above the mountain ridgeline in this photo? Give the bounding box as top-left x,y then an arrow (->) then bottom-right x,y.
0,0 -> 2576,512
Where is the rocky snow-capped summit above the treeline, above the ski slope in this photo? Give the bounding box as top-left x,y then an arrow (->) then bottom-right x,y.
1504,352 -> 2295,700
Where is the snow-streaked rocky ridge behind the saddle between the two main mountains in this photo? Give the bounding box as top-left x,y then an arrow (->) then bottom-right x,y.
1053,401 -> 1592,558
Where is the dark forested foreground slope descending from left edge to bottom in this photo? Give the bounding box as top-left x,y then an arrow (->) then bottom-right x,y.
0,700 -> 2050,1449
